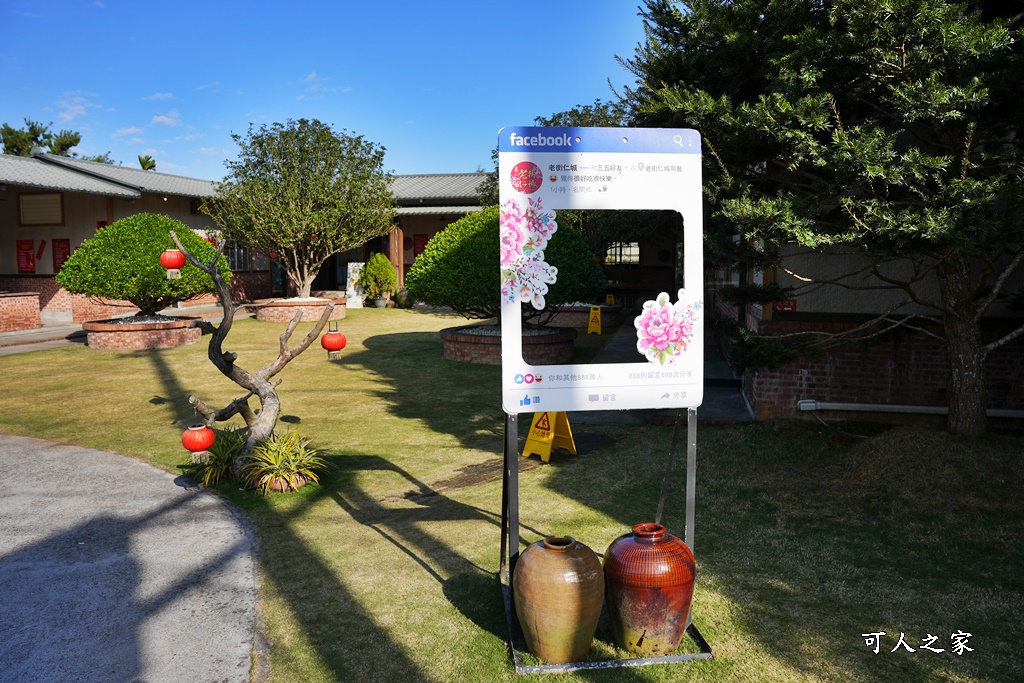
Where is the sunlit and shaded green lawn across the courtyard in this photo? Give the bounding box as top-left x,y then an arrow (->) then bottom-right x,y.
0,309 -> 1024,683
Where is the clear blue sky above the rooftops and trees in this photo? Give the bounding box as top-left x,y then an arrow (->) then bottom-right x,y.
0,0 -> 643,180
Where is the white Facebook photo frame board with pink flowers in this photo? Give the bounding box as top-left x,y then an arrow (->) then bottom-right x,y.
498,127 -> 705,415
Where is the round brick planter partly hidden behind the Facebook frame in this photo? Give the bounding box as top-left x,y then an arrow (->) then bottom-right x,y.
440,326 -> 577,366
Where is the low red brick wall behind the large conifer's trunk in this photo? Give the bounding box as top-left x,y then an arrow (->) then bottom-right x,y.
743,321 -> 1024,419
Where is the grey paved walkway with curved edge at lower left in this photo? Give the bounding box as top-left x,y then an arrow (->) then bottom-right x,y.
0,435 -> 263,683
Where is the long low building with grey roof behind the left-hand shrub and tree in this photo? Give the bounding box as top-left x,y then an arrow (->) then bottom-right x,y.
0,153 -> 486,328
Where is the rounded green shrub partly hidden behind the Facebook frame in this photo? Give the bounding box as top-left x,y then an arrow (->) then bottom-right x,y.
406,206 -> 605,318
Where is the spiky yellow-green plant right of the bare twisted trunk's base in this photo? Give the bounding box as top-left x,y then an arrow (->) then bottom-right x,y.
242,429 -> 327,496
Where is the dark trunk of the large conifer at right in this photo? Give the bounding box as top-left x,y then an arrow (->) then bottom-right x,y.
937,256 -> 988,436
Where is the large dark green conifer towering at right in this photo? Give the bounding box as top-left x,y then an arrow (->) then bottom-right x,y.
624,0 -> 1024,434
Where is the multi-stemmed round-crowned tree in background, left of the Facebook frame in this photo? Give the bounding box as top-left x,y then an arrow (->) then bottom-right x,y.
203,119 -> 394,297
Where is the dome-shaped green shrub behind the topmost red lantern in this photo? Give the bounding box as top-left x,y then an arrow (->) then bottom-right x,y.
56,213 -> 230,314
